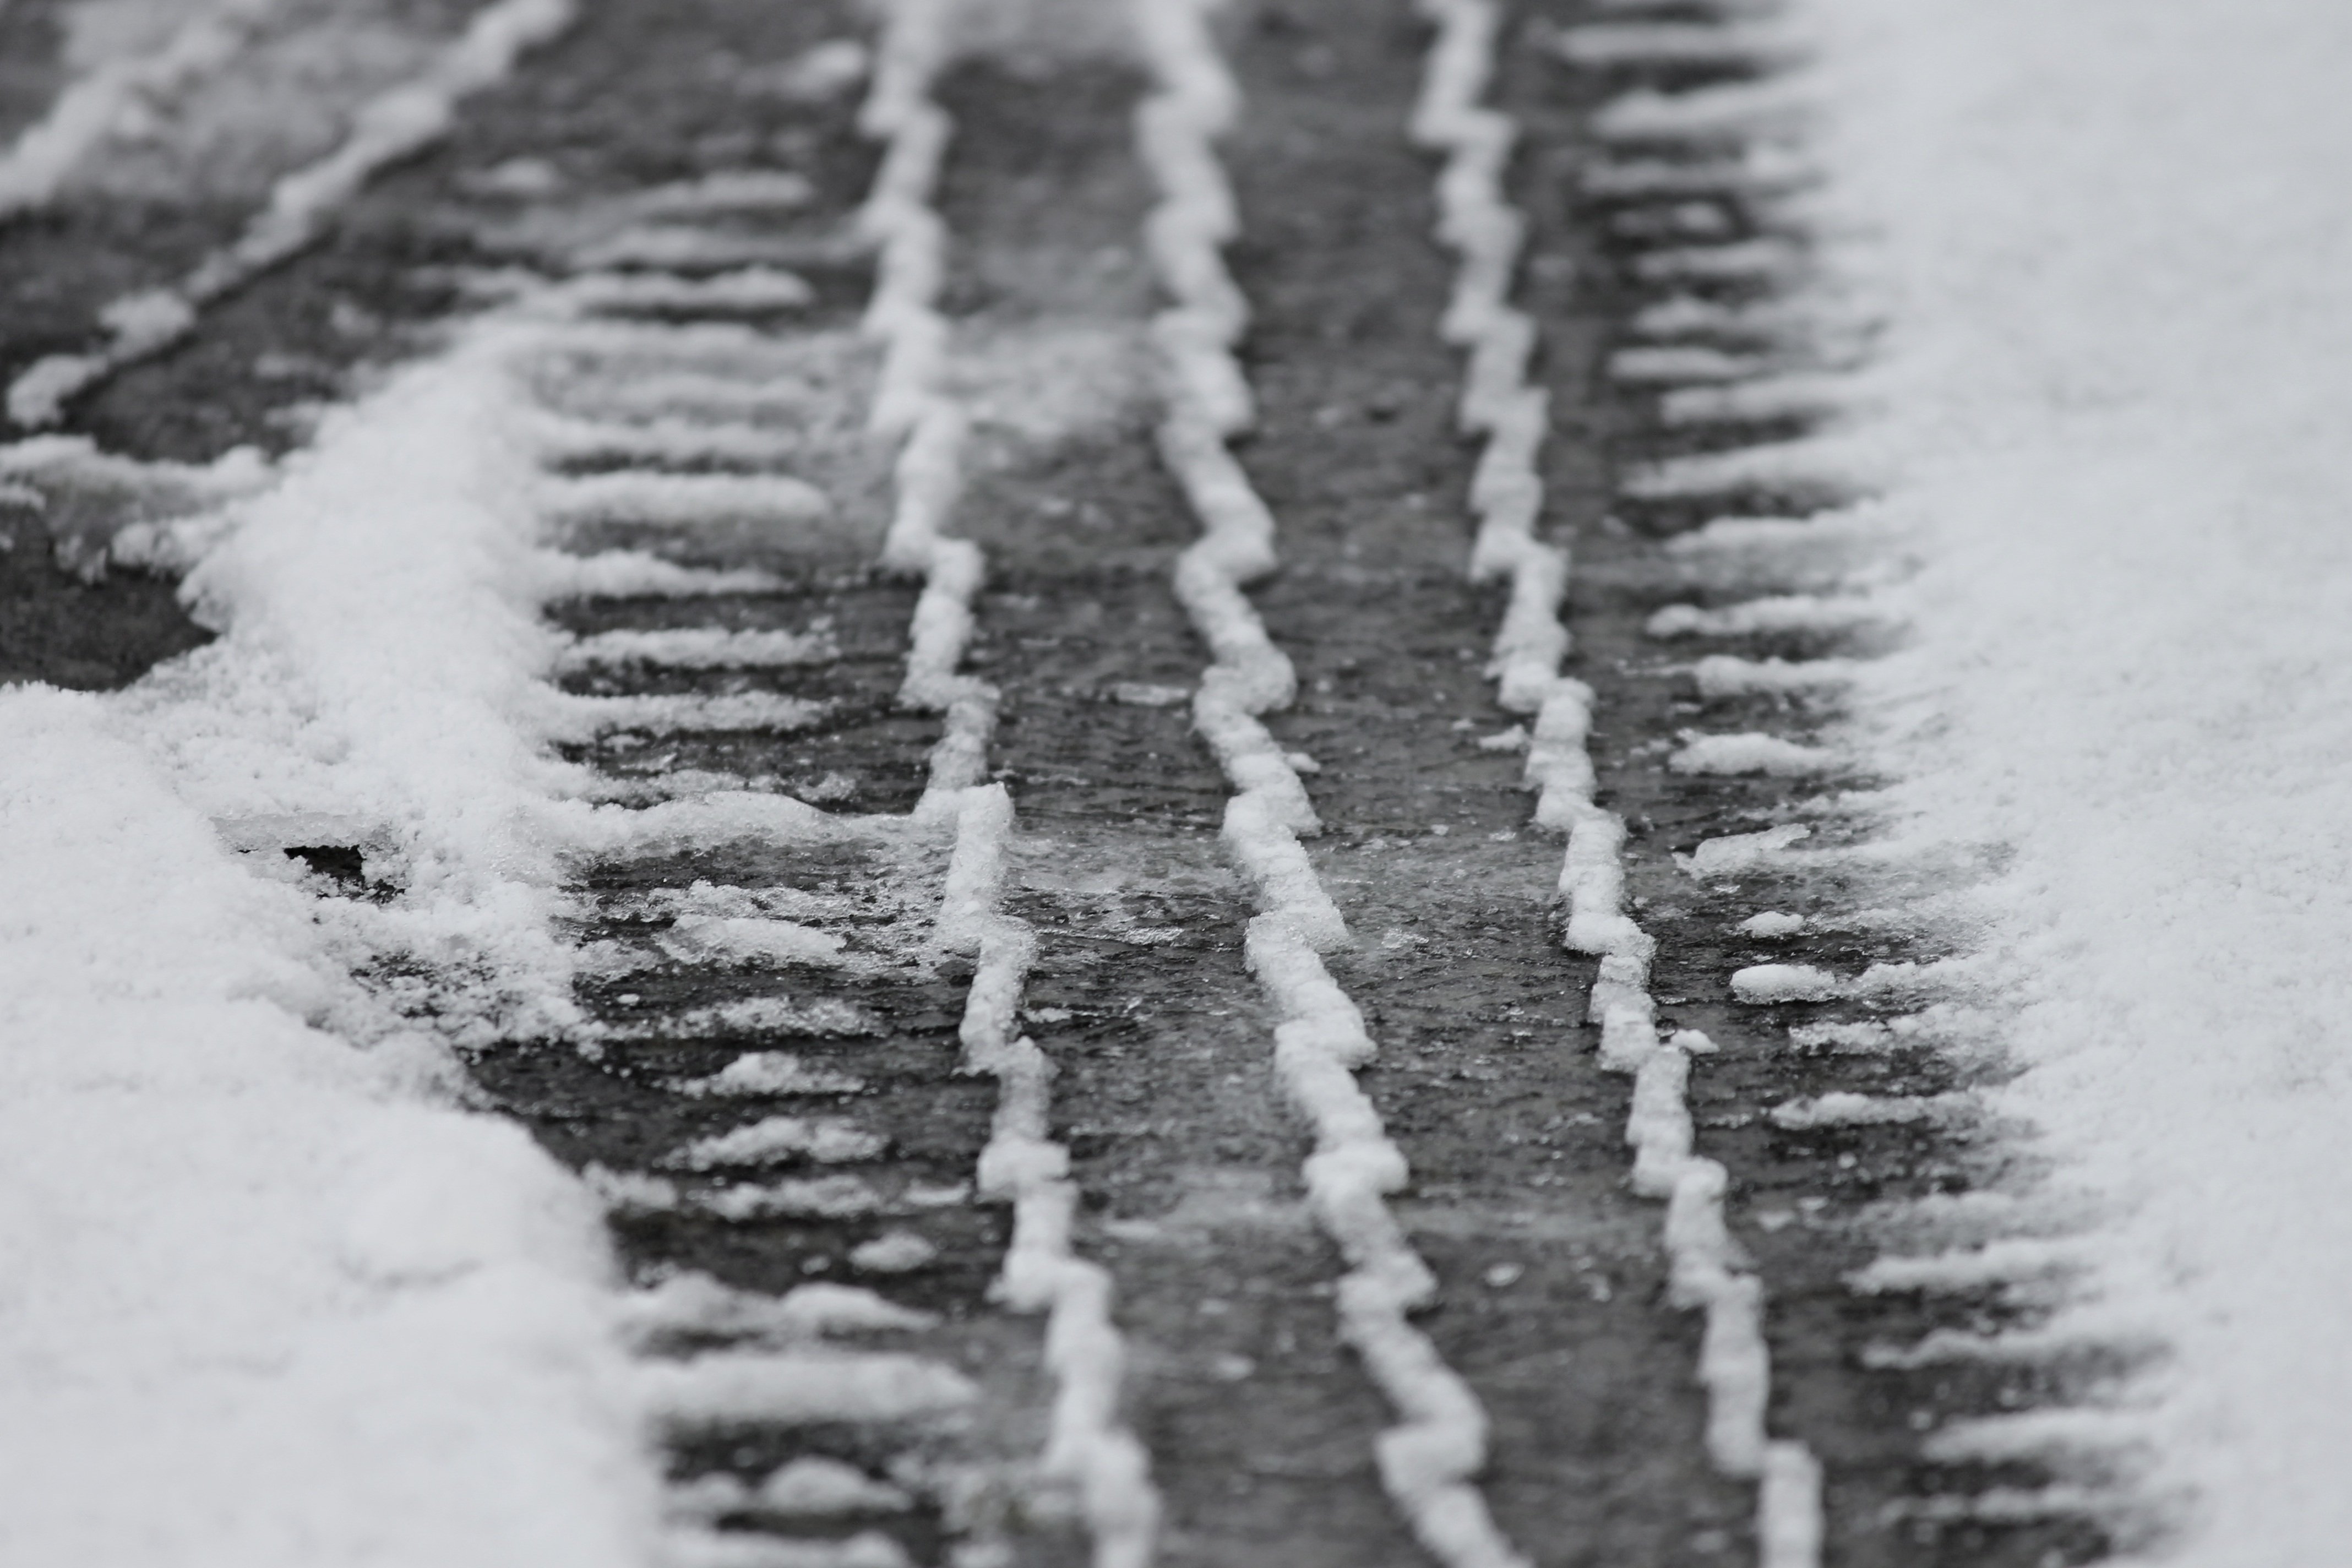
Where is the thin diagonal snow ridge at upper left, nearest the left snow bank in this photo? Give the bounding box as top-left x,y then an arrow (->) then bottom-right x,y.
7,0 -> 574,428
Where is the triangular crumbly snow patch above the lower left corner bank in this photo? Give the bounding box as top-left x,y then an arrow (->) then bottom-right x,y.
120,324 -> 586,1037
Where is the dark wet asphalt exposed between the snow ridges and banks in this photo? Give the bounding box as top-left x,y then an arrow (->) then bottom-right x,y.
0,0 -> 2119,1568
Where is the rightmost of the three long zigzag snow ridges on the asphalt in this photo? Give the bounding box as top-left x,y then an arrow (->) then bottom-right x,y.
1411,0 -> 1821,1568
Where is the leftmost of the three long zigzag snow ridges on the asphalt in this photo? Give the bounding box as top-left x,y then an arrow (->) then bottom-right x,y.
858,0 -> 1159,1568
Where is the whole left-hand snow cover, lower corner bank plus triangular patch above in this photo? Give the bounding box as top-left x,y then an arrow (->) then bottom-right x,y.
0,324 -> 656,1568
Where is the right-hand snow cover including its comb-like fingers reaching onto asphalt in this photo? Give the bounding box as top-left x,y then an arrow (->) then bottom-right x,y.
1599,0 -> 2352,1568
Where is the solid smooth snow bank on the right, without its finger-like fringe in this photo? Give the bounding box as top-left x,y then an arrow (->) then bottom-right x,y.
1799,0 -> 2352,1568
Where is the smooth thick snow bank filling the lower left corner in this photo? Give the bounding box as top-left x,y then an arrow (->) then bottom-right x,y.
0,689 -> 654,1568
